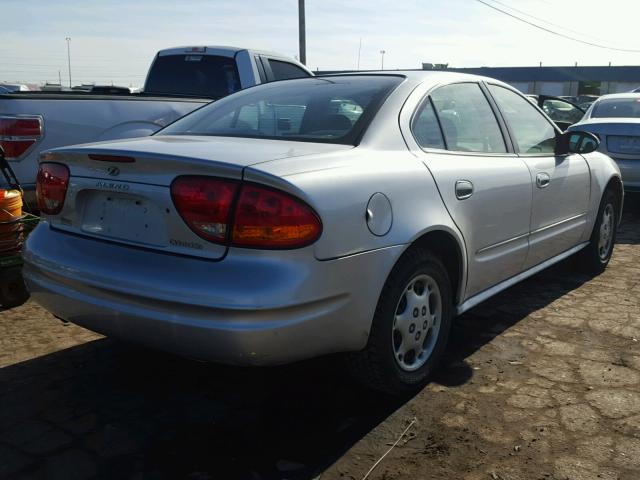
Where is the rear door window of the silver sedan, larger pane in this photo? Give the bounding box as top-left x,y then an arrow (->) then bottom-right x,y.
431,83 -> 507,153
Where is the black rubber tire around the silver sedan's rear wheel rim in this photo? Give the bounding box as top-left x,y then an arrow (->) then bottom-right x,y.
347,248 -> 453,395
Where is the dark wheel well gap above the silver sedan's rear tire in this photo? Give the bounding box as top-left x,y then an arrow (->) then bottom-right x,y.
408,230 -> 464,304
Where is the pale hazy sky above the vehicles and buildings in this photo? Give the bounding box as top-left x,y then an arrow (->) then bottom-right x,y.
0,0 -> 640,86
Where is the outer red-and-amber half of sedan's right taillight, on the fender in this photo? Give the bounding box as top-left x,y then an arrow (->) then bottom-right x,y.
231,184 -> 322,249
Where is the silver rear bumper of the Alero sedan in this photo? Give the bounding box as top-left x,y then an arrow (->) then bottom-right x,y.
24,223 -> 403,365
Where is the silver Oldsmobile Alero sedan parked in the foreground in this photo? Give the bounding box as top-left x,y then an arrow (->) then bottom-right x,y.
25,72 -> 623,392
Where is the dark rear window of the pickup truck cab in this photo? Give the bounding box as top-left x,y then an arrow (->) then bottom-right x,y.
144,54 -> 240,98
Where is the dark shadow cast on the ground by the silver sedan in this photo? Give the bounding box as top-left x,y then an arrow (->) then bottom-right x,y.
0,208 -> 638,480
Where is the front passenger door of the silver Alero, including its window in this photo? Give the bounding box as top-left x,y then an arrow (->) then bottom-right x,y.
488,84 -> 591,268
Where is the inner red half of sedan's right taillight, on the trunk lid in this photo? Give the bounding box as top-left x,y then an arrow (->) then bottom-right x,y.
171,176 -> 238,243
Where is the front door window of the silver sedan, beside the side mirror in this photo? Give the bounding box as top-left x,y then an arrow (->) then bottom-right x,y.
489,85 -> 556,154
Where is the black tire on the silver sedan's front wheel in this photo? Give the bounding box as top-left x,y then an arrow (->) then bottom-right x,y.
578,188 -> 620,275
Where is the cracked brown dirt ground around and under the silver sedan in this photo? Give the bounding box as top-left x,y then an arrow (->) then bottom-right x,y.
0,198 -> 640,480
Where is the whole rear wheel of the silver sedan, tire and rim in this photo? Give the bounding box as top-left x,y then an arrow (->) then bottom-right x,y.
348,249 -> 452,394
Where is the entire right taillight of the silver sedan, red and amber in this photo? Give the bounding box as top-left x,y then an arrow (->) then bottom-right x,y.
171,176 -> 322,249
